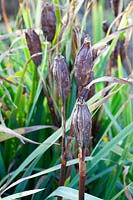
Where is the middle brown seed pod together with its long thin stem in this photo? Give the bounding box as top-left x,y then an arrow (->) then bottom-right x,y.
53,54 -> 70,200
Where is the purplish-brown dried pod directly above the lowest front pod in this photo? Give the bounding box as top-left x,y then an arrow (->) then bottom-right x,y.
75,38 -> 93,87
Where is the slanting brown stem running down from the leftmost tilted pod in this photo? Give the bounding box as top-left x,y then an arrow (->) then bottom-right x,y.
37,67 -> 59,127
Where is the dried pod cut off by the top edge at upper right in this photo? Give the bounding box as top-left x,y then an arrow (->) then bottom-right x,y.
111,0 -> 123,17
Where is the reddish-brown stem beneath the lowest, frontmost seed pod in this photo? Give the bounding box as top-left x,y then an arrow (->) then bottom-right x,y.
79,147 -> 85,200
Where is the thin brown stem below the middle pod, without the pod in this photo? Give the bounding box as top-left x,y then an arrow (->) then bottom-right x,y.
58,99 -> 67,200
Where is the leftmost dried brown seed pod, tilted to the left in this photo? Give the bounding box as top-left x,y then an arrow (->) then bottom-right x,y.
25,29 -> 42,66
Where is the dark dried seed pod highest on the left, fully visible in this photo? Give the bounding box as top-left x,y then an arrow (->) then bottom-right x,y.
41,3 -> 56,42
